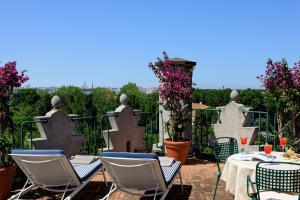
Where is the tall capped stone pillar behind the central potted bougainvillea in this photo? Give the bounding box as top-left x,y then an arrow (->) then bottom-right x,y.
153,57 -> 196,151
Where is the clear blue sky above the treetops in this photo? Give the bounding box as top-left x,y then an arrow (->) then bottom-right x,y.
0,0 -> 300,89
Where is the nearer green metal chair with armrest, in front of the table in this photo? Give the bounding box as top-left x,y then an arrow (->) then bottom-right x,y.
247,162 -> 300,200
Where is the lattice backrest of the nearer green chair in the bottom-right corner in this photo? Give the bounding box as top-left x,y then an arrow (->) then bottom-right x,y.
256,162 -> 300,194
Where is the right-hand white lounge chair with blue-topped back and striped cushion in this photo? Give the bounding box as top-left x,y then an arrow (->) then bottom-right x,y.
100,152 -> 182,199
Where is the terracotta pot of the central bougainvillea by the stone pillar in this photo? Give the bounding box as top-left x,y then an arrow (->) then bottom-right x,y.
164,140 -> 191,164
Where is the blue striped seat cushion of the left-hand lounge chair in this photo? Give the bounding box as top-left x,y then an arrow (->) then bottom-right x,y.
73,160 -> 102,181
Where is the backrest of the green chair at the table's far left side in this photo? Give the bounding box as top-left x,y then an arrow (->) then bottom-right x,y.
213,137 -> 239,161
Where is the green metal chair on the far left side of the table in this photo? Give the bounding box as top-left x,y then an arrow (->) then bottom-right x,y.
213,137 -> 239,199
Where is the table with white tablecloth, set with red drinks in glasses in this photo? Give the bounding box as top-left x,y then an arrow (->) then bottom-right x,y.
221,136 -> 300,200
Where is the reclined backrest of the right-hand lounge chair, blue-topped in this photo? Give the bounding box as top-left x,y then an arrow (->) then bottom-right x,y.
100,152 -> 167,191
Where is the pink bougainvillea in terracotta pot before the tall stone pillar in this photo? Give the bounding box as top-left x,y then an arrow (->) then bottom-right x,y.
149,52 -> 193,164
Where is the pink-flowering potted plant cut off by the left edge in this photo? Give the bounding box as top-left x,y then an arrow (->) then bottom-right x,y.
0,62 -> 28,200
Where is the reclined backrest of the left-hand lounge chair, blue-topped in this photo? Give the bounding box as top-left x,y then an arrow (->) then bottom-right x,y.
10,150 -> 81,187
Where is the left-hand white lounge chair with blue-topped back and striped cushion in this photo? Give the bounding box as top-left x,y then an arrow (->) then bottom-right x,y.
10,150 -> 104,200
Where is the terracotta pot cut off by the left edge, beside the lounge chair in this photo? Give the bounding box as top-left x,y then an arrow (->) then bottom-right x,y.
0,165 -> 16,200
